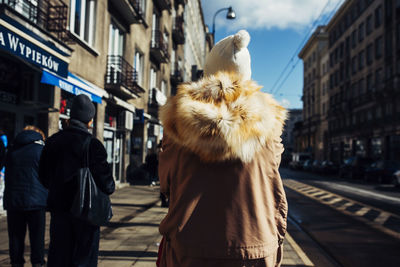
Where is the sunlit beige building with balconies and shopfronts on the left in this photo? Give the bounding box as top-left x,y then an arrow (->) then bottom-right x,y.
0,0 -> 211,188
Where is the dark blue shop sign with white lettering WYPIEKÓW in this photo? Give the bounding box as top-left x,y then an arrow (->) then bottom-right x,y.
0,25 -> 68,77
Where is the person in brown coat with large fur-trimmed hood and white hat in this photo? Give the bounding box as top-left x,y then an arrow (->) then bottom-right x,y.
159,30 -> 287,267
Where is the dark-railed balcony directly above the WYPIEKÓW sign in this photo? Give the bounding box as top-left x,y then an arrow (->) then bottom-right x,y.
0,0 -> 71,42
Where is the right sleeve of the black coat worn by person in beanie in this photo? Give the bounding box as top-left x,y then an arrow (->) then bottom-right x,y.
89,138 -> 115,195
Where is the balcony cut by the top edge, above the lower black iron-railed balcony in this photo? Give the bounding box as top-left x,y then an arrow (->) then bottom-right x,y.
110,0 -> 145,24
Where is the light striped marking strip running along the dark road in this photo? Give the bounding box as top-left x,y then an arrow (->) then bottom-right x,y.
283,179 -> 400,239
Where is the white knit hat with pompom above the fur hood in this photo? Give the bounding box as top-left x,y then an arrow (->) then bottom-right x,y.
204,30 -> 251,80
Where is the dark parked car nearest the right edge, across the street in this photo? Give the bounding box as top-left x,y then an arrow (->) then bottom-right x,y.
364,160 -> 400,184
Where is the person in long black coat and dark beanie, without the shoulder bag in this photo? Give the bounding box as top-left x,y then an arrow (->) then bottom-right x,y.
39,95 -> 115,267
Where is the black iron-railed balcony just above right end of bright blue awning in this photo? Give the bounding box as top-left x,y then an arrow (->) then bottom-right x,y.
105,56 -> 145,99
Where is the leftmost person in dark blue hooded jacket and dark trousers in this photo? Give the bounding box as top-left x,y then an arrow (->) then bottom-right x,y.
3,126 -> 47,267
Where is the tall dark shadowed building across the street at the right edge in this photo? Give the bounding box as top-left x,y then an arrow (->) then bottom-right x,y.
327,0 -> 400,161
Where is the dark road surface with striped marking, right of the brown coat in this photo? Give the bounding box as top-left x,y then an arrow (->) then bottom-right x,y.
281,169 -> 400,267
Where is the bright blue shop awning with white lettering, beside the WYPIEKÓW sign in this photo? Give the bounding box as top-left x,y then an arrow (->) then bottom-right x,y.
40,70 -> 107,104
